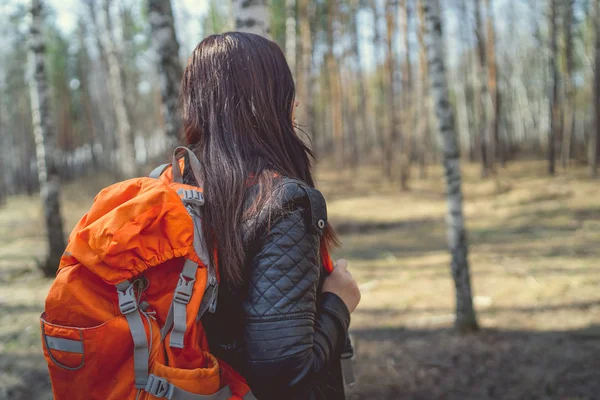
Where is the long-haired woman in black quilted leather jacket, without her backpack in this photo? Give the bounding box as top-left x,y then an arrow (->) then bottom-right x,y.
182,32 -> 360,399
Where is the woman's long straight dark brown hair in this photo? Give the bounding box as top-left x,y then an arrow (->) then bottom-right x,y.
181,32 -> 335,286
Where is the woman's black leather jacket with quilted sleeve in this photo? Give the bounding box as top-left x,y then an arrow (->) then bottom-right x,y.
203,178 -> 350,400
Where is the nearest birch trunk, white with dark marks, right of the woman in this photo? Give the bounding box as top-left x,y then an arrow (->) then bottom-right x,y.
424,0 -> 477,332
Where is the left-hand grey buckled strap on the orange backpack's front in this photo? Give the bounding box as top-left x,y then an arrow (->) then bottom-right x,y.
116,281 -> 148,389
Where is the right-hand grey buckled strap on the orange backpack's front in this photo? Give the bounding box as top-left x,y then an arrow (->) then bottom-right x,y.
165,259 -> 198,349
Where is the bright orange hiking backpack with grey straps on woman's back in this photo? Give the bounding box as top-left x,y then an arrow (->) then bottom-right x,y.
41,147 -> 254,400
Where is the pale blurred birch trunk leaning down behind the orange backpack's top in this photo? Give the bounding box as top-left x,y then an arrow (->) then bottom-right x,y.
97,0 -> 137,178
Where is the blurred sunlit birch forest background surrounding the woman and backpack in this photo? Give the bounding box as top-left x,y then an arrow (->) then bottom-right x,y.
0,0 -> 600,399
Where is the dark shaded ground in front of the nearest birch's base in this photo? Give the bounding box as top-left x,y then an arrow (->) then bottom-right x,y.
349,324 -> 600,400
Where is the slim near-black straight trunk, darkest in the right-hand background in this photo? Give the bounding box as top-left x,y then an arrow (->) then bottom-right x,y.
548,0 -> 560,175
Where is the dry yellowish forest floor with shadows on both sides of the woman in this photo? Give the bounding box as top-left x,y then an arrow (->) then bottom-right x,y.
0,161 -> 600,400
